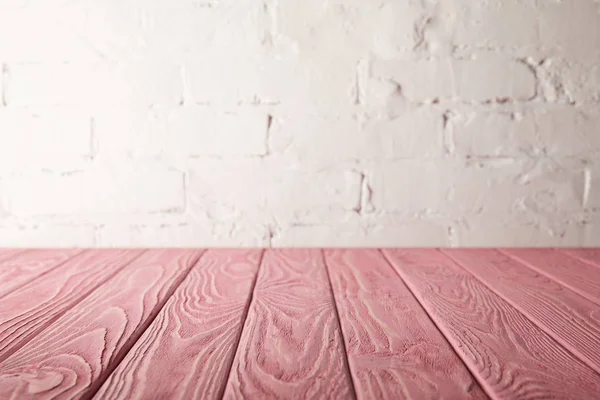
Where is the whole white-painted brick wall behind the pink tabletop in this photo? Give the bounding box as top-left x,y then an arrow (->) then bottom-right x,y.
0,0 -> 600,247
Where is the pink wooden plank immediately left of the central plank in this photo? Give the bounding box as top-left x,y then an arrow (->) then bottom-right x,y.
95,250 -> 262,400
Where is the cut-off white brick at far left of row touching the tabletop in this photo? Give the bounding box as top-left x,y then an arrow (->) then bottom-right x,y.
0,223 -> 96,248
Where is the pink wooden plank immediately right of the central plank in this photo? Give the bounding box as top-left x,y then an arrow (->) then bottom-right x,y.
325,249 -> 487,399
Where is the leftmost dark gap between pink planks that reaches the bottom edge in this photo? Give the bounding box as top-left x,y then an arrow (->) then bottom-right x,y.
81,250 -> 207,400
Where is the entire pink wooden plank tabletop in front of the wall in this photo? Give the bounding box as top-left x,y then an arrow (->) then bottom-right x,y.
0,249 -> 600,399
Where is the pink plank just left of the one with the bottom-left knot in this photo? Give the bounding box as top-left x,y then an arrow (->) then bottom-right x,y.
0,250 -> 141,362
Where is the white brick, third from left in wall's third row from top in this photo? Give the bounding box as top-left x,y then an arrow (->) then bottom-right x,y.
270,109 -> 443,165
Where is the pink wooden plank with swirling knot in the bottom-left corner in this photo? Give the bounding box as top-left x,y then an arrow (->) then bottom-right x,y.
0,250 -> 201,399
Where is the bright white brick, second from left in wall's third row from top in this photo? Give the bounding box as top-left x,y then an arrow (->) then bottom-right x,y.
94,106 -> 269,159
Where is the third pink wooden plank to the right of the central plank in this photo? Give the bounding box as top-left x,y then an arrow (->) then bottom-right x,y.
444,250 -> 600,373
